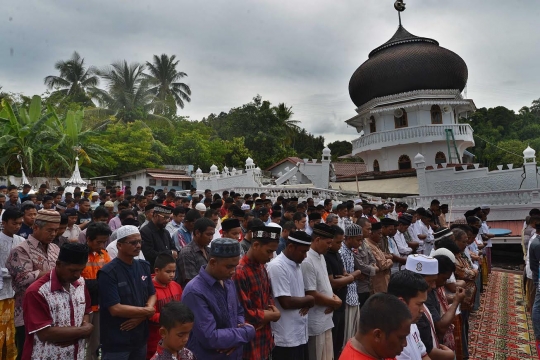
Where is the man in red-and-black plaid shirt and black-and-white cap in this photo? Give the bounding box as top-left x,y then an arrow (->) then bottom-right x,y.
233,226 -> 281,360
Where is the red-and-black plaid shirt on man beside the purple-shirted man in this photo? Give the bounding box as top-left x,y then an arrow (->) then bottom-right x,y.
233,255 -> 274,360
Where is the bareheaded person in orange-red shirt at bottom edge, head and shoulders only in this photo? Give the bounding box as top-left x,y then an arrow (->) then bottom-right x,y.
339,293 -> 412,360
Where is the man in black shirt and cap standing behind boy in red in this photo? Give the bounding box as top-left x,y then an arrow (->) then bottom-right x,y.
141,205 -> 177,269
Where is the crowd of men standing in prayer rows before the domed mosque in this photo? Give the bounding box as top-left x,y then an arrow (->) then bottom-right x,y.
0,184 -> 498,360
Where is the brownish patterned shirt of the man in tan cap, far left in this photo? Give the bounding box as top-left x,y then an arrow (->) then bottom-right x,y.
6,235 -> 60,326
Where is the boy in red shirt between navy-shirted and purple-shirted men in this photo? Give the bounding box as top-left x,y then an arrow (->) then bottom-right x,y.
146,253 -> 185,359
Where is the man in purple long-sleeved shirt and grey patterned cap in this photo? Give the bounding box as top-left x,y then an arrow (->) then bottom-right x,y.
182,238 -> 255,360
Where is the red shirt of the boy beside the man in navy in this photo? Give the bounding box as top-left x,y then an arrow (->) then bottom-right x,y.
146,278 -> 182,359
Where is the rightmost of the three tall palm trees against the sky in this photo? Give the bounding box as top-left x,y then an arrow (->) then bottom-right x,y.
146,54 -> 191,114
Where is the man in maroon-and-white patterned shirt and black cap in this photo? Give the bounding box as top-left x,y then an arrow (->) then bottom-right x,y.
22,243 -> 94,360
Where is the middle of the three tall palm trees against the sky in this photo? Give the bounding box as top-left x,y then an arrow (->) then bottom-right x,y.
90,60 -> 170,124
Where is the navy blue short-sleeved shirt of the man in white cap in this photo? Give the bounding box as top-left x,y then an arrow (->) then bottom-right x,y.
98,258 -> 156,352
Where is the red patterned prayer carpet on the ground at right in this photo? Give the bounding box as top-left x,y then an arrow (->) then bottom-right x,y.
469,271 -> 538,360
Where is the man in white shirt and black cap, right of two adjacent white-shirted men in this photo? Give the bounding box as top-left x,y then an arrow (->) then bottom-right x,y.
301,224 -> 342,360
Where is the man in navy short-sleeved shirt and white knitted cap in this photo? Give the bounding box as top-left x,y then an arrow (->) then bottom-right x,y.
98,225 -> 156,360
